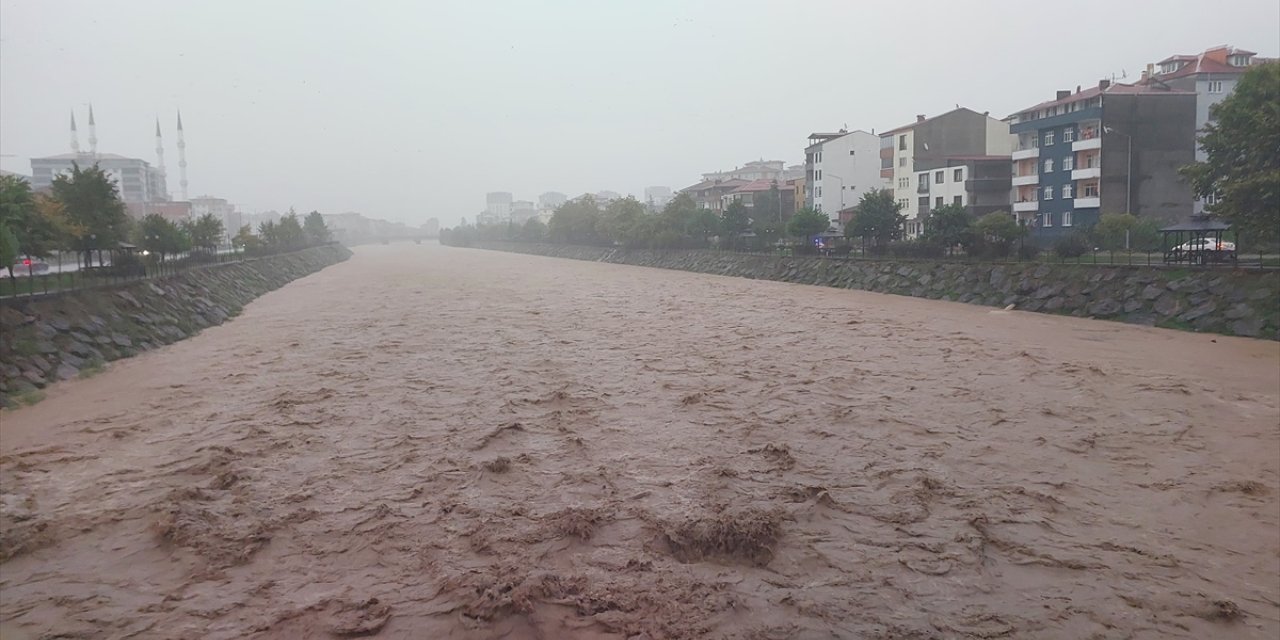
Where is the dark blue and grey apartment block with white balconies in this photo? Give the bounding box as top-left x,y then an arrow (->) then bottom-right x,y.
1010,81 -> 1196,236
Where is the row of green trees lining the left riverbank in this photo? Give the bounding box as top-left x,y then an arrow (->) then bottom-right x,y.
0,165 -> 330,276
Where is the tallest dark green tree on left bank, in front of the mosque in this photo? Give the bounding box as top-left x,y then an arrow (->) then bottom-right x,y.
52,164 -> 129,264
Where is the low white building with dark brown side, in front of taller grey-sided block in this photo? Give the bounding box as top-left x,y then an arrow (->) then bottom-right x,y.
910,156 -> 1012,224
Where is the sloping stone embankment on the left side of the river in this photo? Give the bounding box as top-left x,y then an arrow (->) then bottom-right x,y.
0,244 -> 351,406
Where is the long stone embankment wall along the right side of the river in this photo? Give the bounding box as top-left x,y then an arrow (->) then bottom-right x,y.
480,242 -> 1280,340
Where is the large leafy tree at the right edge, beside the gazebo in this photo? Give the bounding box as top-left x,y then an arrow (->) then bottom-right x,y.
1183,64 -> 1280,242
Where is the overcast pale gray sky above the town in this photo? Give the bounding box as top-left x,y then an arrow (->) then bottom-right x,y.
0,0 -> 1280,225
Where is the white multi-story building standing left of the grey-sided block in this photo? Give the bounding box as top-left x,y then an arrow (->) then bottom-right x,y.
804,129 -> 881,224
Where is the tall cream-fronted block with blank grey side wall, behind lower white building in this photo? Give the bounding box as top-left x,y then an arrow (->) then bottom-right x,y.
879,106 -> 1012,236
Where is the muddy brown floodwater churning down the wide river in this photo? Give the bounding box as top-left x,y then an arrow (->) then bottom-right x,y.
0,246 -> 1280,640
